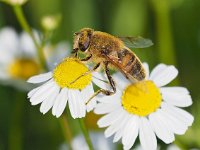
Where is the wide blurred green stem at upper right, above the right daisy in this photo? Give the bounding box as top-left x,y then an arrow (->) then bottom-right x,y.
151,0 -> 176,65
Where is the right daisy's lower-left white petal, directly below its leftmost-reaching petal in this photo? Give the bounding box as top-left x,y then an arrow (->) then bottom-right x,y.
97,108 -> 123,128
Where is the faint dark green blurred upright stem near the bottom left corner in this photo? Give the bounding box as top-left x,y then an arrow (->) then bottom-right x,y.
8,91 -> 25,150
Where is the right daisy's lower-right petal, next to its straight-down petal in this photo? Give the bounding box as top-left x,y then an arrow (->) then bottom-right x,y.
149,111 -> 175,144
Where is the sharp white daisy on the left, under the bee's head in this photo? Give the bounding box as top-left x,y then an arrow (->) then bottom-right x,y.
28,58 -> 107,118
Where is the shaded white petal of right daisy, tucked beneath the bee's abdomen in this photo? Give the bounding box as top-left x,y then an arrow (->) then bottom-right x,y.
112,72 -> 131,90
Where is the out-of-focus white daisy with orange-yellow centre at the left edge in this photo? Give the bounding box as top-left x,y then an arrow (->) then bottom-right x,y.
0,27 -> 41,90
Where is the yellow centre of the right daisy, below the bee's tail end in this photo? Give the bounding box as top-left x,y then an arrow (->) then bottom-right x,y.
122,80 -> 162,116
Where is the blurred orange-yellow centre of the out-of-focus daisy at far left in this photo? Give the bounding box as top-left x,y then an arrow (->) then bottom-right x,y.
8,58 -> 41,80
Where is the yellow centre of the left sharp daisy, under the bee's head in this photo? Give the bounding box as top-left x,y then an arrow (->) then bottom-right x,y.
53,58 -> 92,89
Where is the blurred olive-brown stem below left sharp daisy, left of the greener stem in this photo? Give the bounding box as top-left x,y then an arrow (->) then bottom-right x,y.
60,114 -> 72,150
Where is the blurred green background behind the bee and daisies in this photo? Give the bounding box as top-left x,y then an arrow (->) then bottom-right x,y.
0,0 -> 200,150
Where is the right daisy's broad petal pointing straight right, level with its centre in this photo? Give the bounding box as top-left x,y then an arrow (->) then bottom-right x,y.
161,89 -> 192,107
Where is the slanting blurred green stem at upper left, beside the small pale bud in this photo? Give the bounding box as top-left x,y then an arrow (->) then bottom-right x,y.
13,5 -> 47,69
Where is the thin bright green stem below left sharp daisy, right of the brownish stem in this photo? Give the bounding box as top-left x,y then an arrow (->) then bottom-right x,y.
79,118 -> 93,150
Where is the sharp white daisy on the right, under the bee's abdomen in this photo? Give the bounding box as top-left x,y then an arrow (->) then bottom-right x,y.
95,63 -> 194,150
